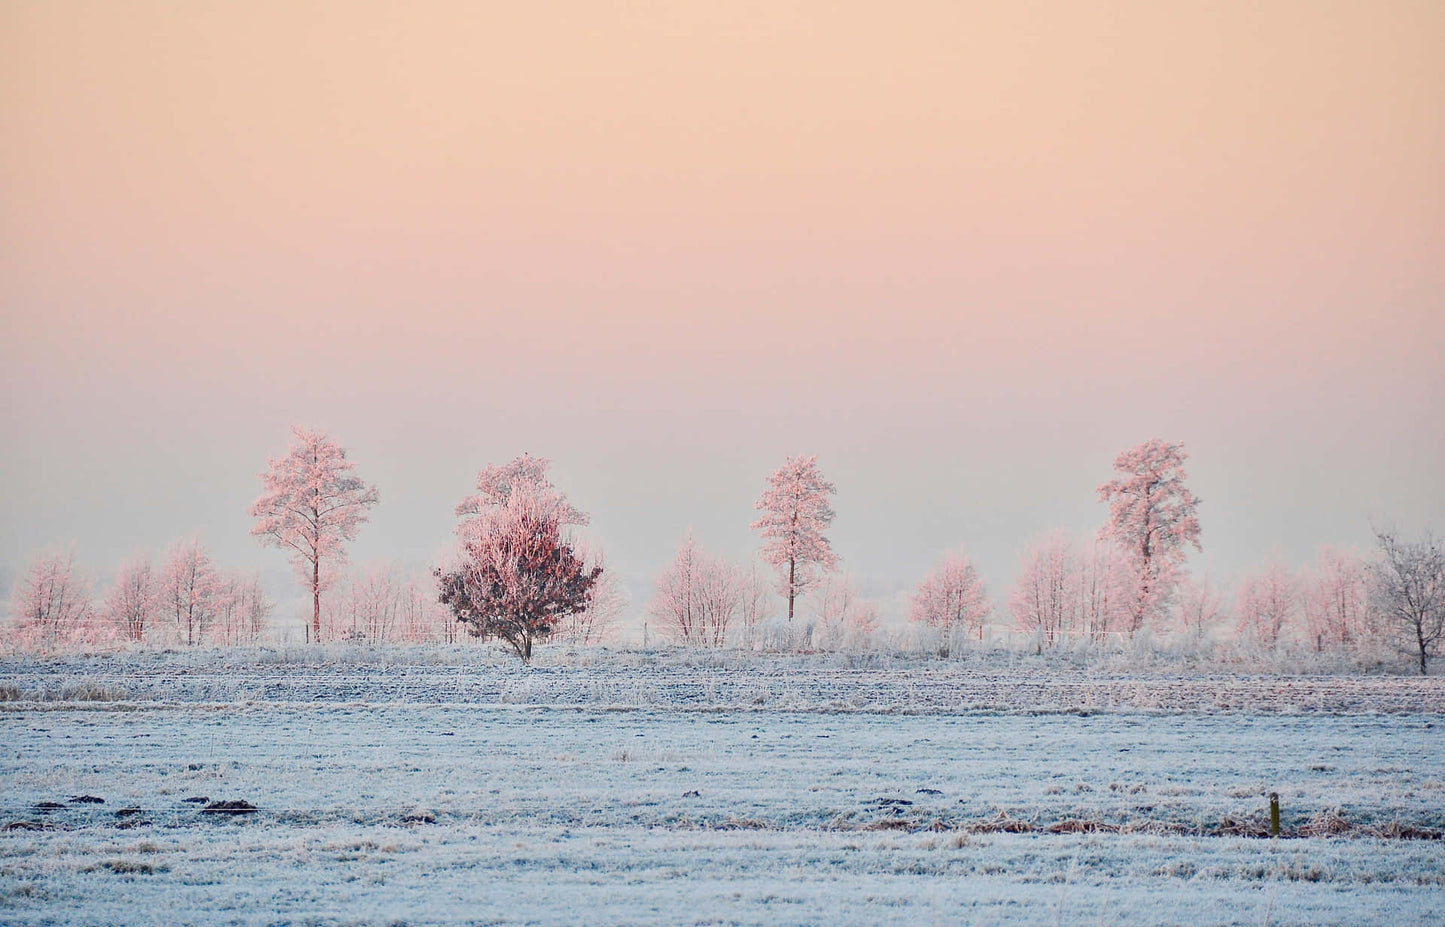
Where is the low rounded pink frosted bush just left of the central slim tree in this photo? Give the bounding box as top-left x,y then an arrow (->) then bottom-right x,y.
647,531 -> 743,647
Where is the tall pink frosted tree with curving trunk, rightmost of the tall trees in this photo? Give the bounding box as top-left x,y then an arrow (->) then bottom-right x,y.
1098,438 -> 1202,634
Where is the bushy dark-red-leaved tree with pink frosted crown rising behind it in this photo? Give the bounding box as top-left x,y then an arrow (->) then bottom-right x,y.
436,455 -> 603,663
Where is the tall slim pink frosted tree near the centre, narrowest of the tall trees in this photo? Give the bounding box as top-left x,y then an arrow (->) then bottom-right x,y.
753,456 -> 838,622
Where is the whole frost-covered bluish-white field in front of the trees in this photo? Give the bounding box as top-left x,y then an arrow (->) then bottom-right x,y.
0,647 -> 1445,924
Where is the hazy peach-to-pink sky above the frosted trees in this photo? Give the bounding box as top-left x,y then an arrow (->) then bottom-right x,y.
0,0 -> 1445,620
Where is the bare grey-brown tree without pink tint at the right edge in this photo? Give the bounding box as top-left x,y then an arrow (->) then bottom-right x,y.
1370,530 -> 1445,676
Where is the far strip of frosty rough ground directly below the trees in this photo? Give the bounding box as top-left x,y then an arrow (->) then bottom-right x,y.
0,645 -> 1445,713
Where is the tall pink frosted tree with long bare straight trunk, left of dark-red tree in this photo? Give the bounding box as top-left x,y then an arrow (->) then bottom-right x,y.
251,427 -> 377,641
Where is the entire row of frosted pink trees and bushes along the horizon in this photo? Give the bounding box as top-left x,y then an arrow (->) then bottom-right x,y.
12,429 -> 1445,671
